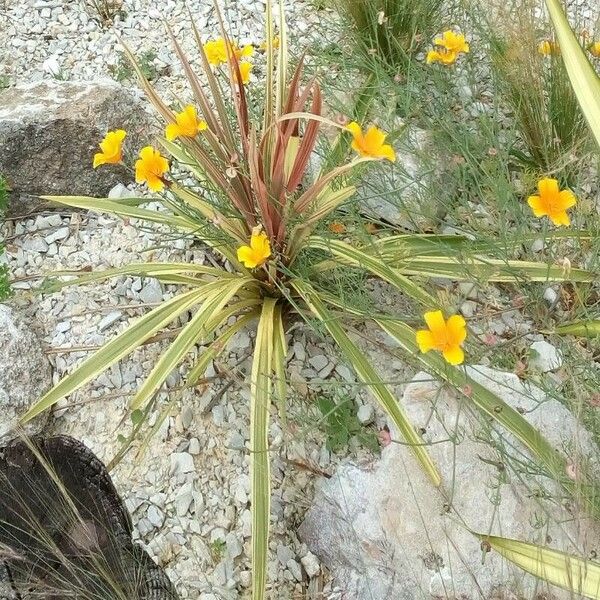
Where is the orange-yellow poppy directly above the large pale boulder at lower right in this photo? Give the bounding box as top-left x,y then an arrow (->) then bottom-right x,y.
417,310 -> 467,365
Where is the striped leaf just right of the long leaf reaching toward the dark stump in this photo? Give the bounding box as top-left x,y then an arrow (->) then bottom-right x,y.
130,277 -> 250,410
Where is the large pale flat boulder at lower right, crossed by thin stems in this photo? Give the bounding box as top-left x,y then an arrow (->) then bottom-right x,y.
299,367 -> 600,600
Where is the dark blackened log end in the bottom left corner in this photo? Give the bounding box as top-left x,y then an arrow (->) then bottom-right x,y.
0,436 -> 178,600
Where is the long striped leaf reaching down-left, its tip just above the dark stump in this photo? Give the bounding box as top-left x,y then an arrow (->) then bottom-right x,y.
21,282 -> 212,423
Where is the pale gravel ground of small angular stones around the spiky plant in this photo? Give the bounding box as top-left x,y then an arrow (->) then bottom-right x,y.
0,0 -> 600,600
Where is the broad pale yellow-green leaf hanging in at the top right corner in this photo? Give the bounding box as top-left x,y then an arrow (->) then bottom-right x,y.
546,0 -> 600,146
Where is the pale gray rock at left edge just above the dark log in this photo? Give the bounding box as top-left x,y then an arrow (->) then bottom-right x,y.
0,304 -> 52,444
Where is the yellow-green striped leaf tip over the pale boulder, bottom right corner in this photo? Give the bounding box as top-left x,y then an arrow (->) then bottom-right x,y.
475,533 -> 600,600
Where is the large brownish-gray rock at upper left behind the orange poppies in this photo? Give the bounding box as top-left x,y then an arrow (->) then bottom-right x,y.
0,81 -> 150,215
